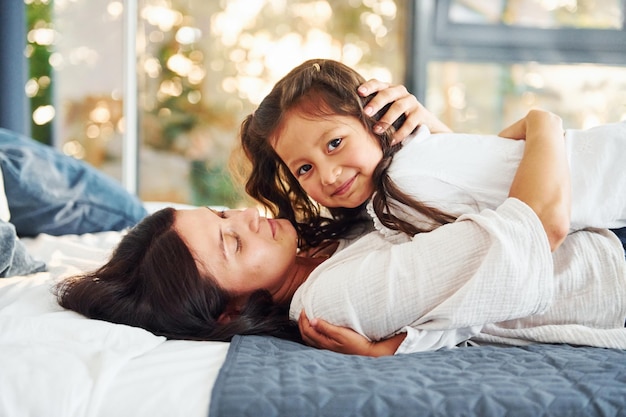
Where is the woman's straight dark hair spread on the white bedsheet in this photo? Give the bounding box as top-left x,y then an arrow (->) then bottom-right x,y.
56,208 -> 299,341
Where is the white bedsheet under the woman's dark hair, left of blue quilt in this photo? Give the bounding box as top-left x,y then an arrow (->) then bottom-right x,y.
0,232 -> 228,417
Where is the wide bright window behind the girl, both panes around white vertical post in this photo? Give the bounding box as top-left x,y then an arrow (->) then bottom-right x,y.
27,0 -> 406,206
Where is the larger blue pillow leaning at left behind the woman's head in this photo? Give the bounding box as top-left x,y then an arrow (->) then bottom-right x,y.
0,129 -> 147,236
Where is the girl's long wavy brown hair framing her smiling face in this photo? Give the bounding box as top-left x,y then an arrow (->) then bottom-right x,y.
235,59 -> 455,246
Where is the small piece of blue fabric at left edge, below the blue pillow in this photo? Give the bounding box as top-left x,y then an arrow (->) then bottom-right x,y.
0,220 -> 46,278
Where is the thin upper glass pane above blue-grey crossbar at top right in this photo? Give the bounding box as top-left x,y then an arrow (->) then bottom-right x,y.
448,0 -> 624,30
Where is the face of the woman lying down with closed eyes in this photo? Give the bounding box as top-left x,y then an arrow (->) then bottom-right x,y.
174,207 -> 297,301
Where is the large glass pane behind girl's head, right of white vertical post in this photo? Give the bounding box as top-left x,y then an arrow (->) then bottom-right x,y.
135,0 -> 405,206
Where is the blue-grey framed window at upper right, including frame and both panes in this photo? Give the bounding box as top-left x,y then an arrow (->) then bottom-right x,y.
409,0 -> 626,133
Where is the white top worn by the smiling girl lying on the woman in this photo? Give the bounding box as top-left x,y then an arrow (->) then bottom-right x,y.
368,122 -> 626,234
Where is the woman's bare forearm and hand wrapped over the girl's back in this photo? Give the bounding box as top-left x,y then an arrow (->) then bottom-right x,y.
500,110 -> 571,251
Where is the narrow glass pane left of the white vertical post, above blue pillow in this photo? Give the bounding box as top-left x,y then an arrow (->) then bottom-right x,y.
50,1 -> 124,177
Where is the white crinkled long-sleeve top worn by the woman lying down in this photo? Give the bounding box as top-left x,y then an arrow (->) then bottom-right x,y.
290,198 -> 626,353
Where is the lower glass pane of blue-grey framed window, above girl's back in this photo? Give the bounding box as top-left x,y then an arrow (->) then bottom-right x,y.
426,62 -> 626,133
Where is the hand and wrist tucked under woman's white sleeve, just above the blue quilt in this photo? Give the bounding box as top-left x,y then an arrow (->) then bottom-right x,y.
298,311 -> 406,356
